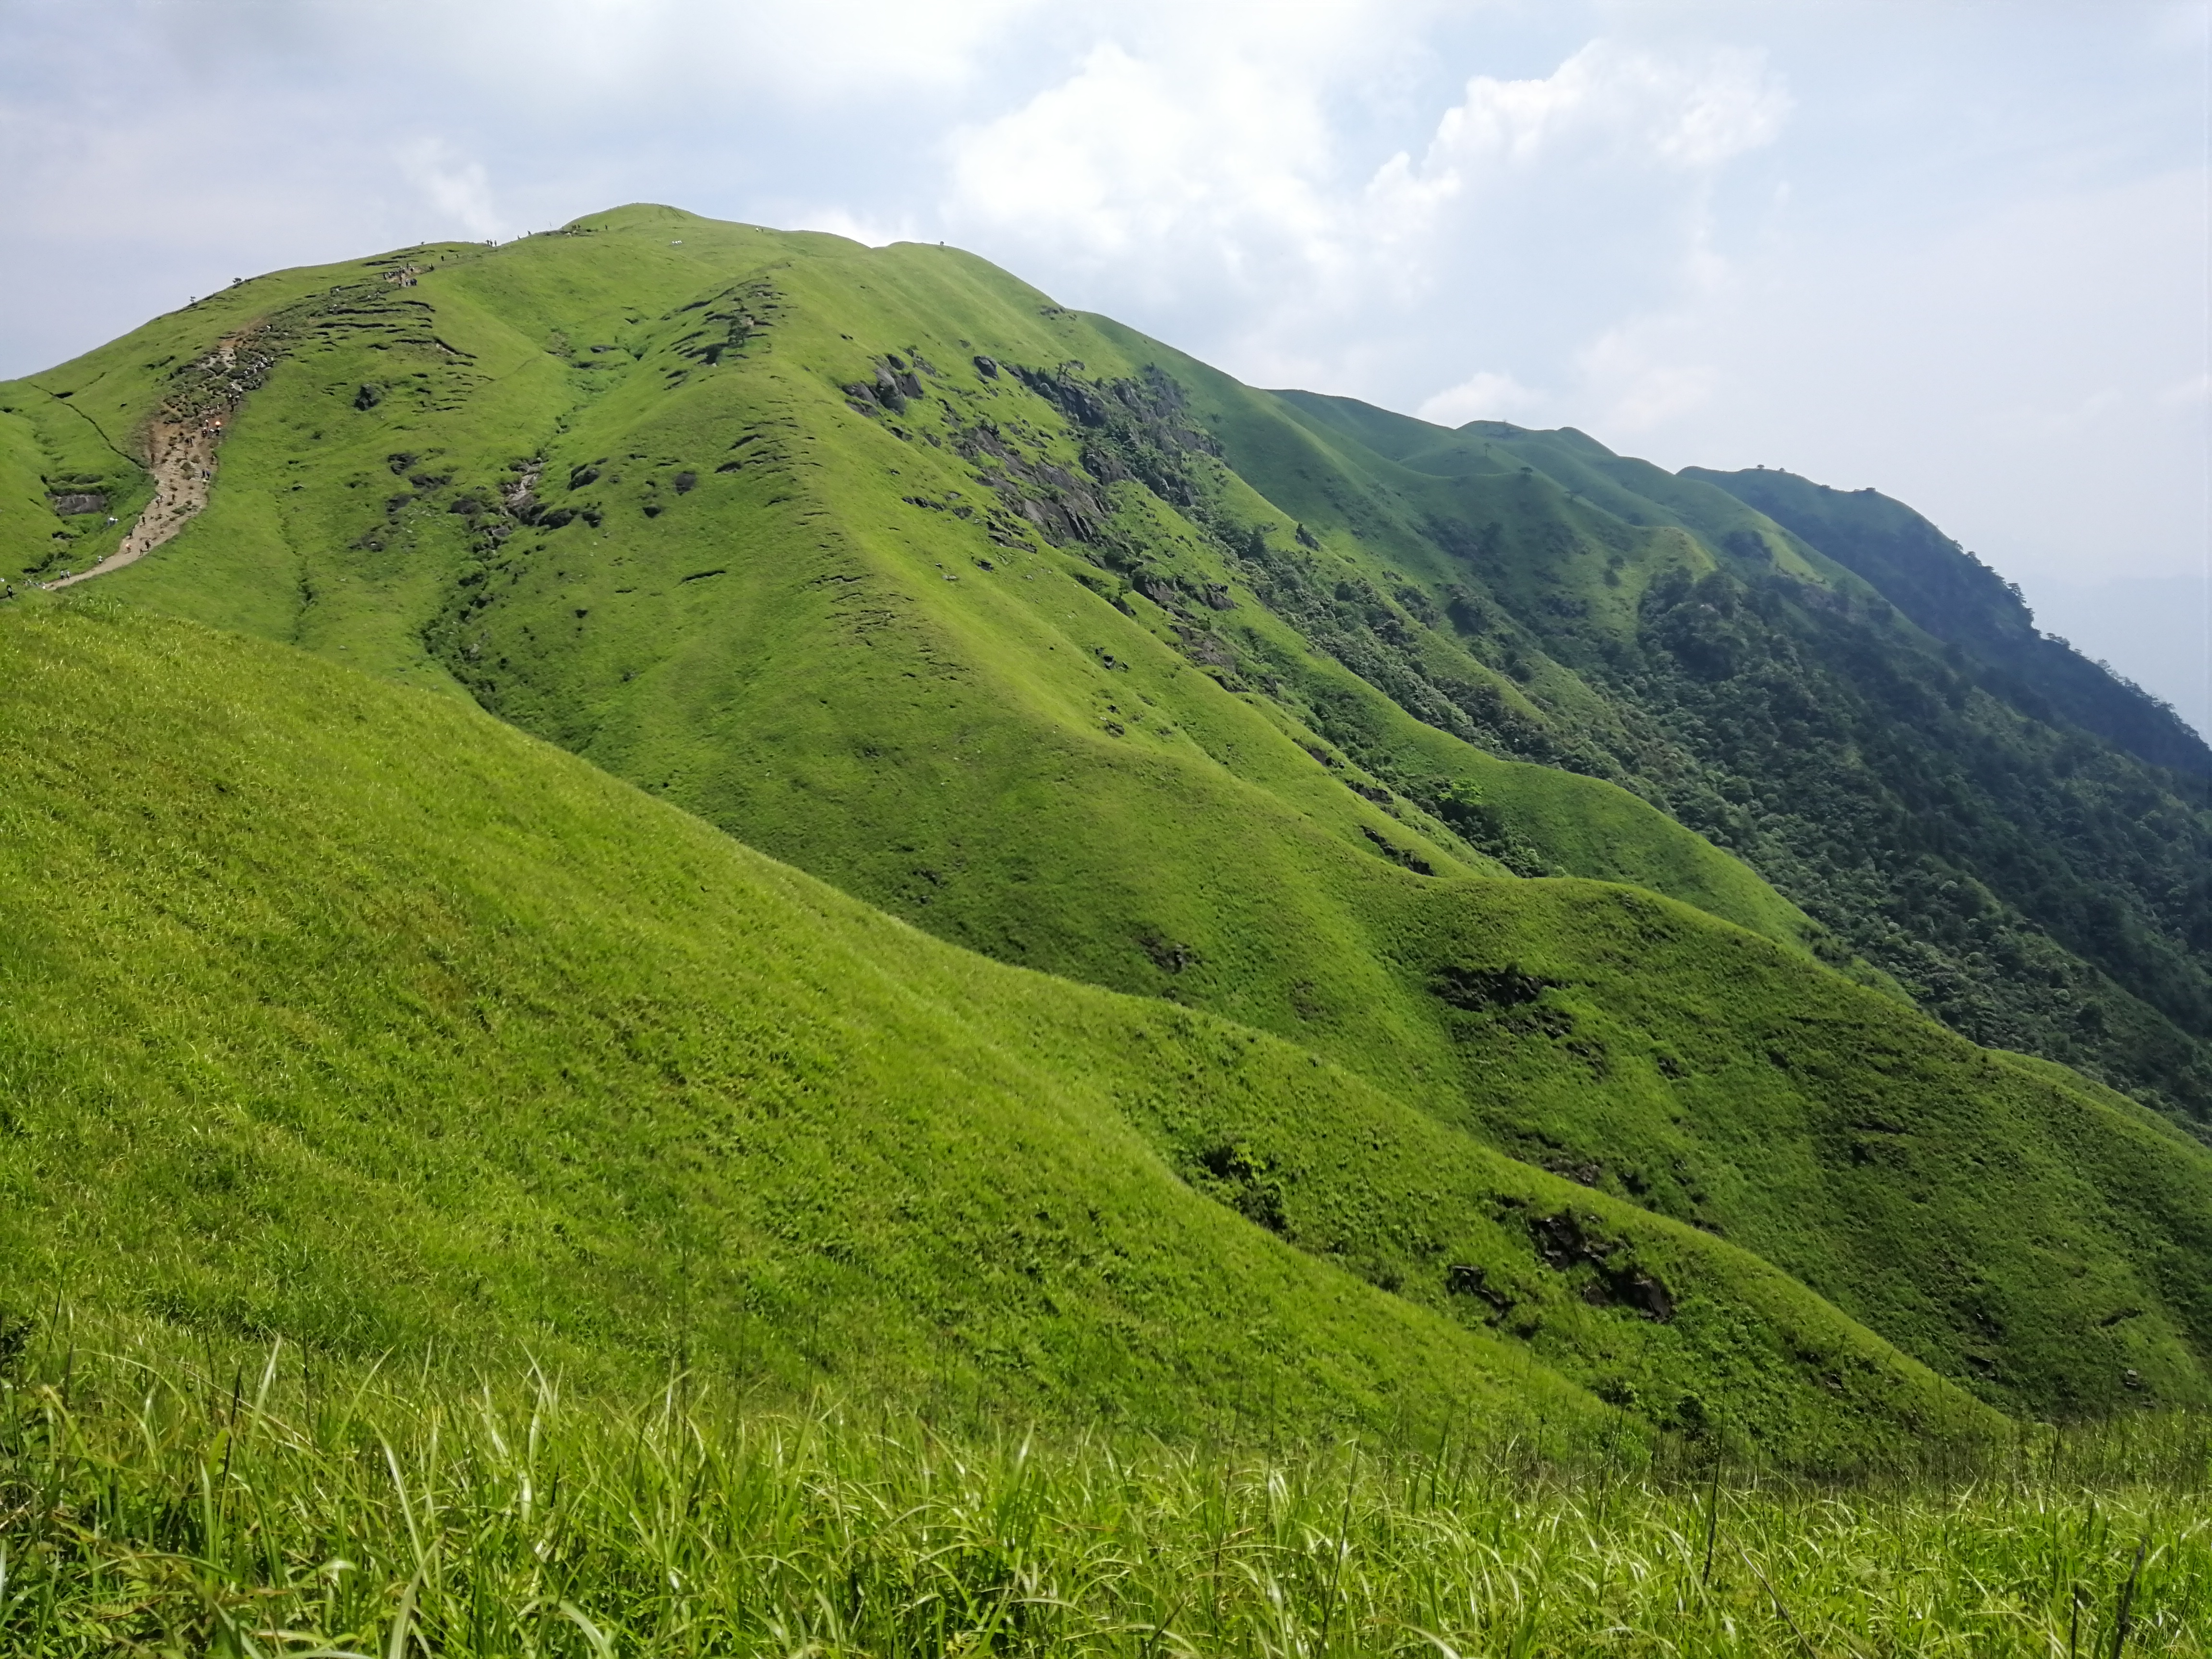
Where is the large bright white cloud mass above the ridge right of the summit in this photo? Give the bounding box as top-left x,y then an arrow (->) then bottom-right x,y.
940,30 -> 1790,409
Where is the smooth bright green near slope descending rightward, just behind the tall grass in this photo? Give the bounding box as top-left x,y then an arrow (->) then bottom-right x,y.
0,600 -> 2026,1464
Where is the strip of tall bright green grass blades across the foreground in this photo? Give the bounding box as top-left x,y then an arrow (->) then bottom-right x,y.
0,1349 -> 2212,1659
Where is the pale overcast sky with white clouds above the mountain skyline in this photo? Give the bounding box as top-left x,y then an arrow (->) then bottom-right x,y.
0,0 -> 2212,721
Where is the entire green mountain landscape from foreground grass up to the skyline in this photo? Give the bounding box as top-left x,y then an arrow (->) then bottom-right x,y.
0,206 -> 2212,1659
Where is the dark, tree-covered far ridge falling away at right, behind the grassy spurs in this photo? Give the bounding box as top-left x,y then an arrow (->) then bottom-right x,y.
1223,394 -> 2212,1132
